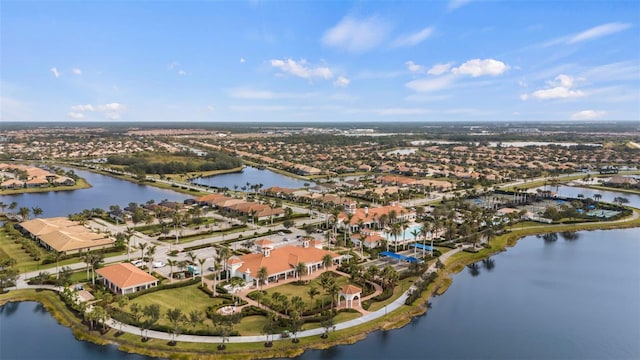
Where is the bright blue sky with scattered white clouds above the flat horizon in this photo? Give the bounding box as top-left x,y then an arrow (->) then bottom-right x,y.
0,0 -> 640,122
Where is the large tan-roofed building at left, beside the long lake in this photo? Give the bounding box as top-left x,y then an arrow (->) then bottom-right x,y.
18,217 -> 114,254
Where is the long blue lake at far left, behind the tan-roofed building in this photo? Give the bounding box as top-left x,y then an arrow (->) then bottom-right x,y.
0,169 -> 192,217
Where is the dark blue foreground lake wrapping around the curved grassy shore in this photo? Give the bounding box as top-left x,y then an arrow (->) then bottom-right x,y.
0,228 -> 640,360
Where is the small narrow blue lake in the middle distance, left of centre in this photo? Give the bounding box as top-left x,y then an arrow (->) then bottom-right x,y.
193,166 -> 315,191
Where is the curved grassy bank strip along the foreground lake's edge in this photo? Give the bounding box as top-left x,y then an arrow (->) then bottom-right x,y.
0,208 -> 640,359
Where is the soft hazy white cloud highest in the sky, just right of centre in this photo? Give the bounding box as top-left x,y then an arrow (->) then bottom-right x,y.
322,16 -> 389,53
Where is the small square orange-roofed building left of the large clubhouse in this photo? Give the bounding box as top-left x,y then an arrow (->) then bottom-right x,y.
96,263 -> 158,295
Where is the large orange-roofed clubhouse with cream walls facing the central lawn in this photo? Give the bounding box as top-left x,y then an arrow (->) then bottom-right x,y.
229,240 -> 342,286
